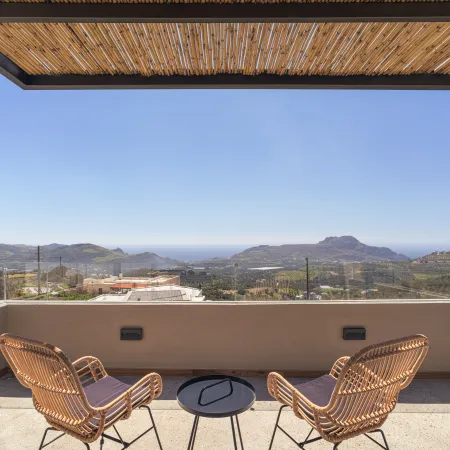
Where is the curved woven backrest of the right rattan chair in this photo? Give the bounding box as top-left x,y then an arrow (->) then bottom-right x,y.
327,335 -> 428,428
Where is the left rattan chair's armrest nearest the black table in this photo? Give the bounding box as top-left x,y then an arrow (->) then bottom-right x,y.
93,372 -> 163,418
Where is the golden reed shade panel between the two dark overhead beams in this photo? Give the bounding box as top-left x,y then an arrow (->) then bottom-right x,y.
0,22 -> 450,76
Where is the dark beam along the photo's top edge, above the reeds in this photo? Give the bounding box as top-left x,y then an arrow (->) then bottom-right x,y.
0,1 -> 450,23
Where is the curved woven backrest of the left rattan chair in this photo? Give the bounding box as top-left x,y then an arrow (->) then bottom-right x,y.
0,334 -> 91,432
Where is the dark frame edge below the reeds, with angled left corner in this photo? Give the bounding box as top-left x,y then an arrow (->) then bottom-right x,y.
0,52 -> 450,90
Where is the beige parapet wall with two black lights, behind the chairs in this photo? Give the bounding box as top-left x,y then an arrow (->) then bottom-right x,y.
0,301 -> 450,374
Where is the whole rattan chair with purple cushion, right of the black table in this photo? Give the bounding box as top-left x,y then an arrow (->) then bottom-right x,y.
267,335 -> 428,450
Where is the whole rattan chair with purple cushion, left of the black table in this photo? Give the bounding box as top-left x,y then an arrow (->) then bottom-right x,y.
0,334 -> 162,450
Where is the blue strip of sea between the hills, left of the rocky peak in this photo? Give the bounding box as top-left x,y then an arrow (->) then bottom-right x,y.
119,245 -> 246,261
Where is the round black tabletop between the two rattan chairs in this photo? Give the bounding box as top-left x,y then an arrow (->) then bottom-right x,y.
177,375 -> 256,417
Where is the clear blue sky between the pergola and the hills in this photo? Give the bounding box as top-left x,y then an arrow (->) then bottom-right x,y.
0,77 -> 450,247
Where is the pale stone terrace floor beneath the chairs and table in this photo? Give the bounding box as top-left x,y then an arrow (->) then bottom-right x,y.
0,375 -> 450,450
